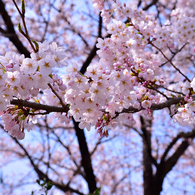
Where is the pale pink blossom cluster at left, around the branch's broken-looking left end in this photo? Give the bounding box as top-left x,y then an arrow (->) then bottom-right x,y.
0,42 -> 66,139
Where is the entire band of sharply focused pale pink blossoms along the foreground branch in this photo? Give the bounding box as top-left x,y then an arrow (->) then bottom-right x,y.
0,0 -> 195,139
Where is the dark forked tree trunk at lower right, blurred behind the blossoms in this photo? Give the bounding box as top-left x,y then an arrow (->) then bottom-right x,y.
140,114 -> 195,195
